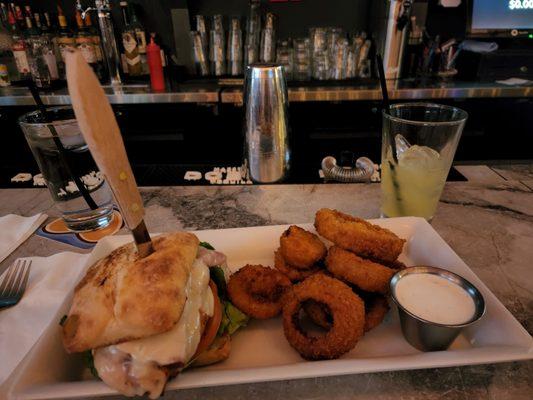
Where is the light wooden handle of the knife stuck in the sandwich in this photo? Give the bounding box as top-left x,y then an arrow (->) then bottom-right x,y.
65,51 -> 144,229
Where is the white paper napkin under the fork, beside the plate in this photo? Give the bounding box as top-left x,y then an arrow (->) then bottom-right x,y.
0,252 -> 89,388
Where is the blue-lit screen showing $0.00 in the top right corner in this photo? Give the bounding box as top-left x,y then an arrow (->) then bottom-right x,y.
472,0 -> 533,30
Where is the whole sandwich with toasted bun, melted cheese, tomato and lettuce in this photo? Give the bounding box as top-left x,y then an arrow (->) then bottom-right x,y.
61,232 -> 247,399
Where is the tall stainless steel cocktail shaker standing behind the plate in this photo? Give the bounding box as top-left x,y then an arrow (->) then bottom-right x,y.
243,64 -> 290,183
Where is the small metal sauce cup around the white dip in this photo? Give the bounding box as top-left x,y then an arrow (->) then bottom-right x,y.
390,266 -> 485,351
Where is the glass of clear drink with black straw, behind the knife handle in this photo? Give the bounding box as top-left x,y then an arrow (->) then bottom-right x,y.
19,107 -> 113,232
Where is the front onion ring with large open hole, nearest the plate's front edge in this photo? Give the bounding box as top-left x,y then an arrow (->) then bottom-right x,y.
283,274 -> 365,360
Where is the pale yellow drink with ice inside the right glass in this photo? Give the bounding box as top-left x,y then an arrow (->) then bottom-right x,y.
381,145 -> 451,220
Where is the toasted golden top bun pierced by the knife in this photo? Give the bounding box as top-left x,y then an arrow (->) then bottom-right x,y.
63,232 -> 199,353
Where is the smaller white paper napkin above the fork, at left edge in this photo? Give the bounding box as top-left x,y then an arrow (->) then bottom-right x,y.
0,214 -> 48,262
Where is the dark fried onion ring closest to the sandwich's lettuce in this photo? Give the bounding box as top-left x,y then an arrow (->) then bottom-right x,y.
228,265 -> 291,319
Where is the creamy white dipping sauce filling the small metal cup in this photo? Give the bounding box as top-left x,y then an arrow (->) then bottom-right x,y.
395,273 -> 476,325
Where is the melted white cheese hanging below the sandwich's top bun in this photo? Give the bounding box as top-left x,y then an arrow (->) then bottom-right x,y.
93,258 -> 214,398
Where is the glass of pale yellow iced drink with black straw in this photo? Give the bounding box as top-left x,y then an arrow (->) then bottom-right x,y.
381,103 -> 468,221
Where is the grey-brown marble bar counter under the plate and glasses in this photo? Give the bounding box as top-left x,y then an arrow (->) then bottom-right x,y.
0,165 -> 533,400
